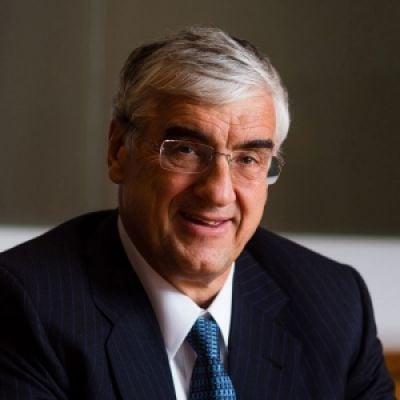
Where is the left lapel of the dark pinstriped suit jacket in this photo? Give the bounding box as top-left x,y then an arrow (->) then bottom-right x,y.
89,216 -> 175,400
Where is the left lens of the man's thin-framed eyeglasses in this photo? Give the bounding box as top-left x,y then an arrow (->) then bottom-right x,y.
160,140 -> 213,173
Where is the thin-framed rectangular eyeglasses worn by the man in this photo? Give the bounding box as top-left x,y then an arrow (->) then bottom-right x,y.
160,140 -> 282,185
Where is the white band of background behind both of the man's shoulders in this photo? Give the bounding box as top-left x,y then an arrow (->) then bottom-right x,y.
0,226 -> 400,349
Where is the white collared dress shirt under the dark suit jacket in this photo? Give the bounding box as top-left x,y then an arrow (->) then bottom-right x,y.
118,219 -> 234,400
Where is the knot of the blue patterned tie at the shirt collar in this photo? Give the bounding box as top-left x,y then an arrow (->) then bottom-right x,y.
186,317 -> 220,360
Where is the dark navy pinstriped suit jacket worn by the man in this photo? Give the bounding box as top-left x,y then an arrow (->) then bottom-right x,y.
0,212 -> 394,400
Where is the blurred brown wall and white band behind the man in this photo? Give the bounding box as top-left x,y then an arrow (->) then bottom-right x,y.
0,0 -> 400,384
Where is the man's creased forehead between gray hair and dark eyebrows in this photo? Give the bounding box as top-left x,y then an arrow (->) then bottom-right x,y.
148,92 -> 275,146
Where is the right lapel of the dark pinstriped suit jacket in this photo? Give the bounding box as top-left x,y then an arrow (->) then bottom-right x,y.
229,251 -> 301,400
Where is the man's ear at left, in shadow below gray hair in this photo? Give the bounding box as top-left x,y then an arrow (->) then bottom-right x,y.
107,118 -> 128,184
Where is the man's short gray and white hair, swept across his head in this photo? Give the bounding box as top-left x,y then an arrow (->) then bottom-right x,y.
113,26 -> 290,148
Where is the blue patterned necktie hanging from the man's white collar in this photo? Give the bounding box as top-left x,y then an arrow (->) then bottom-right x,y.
186,318 -> 236,400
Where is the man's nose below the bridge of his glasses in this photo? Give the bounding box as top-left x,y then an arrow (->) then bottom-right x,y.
194,153 -> 236,207
